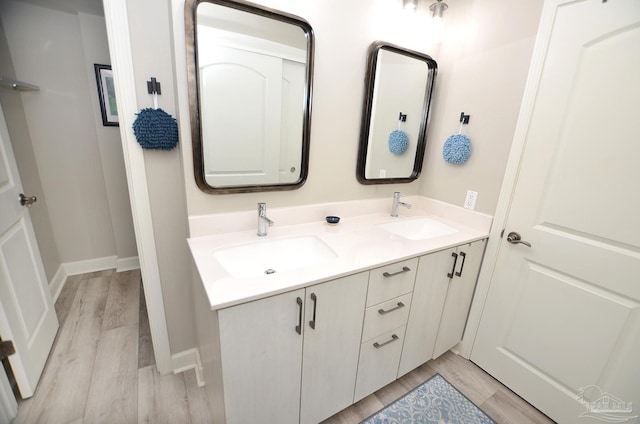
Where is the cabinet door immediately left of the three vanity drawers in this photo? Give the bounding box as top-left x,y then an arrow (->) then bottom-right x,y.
302,272 -> 369,424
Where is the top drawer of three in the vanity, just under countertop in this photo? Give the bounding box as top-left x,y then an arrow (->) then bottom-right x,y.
367,258 -> 418,307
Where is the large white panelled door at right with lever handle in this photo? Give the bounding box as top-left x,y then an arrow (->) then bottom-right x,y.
471,0 -> 640,423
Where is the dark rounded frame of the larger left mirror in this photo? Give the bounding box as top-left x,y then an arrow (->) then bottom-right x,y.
184,0 -> 314,194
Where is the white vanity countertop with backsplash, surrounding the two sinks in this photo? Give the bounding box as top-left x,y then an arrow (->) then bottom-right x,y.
187,196 -> 492,310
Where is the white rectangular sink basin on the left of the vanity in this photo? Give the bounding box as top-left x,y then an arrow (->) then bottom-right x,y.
213,236 -> 336,278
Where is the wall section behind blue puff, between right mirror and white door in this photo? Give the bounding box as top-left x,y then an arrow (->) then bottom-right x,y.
420,0 -> 543,214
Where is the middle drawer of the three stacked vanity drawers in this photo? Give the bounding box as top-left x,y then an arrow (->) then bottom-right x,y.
362,293 -> 411,341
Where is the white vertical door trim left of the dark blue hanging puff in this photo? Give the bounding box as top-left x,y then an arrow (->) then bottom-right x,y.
103,0 -> 173,375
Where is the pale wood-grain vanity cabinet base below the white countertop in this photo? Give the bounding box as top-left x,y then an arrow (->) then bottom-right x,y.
194,235 -> 486,424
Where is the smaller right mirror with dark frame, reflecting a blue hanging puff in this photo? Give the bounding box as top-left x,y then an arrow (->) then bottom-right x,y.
356,41 -> 438,184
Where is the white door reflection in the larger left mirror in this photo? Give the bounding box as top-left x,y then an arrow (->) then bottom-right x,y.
198,26 -> 305,186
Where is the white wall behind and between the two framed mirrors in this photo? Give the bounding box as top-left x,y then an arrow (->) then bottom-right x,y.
174,0 -> 444,215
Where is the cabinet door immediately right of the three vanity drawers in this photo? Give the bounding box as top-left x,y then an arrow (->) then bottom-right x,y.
398,248 -> 457,377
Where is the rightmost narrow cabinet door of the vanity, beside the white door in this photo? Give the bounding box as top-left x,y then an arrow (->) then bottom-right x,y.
433,240 -> 486,358
